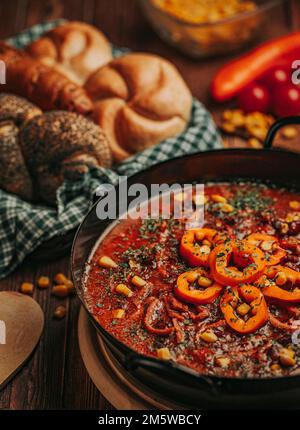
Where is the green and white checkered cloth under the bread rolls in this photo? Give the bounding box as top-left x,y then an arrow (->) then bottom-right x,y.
0,20 -> 222,278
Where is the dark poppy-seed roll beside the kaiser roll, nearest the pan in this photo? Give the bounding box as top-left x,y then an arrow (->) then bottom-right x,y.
20,111 -> 112,204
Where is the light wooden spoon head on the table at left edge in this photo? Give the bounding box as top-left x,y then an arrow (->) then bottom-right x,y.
0,291 -> 44,389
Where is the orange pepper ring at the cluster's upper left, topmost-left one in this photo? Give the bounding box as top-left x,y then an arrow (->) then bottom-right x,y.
179,228 -> 222,266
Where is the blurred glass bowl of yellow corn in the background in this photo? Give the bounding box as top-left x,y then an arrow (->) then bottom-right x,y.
140,0 -> 284,58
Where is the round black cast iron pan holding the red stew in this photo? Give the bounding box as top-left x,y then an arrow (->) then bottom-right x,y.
71,117 -> 300,409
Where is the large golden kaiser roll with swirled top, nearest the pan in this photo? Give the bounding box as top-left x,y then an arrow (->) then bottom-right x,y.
85,53 -> 192,161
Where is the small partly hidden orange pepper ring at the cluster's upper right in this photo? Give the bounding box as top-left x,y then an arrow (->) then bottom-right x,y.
246,233 -> 286,266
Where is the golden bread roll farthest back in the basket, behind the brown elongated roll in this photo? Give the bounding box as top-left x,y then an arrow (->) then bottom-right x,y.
26,21 -> 112,84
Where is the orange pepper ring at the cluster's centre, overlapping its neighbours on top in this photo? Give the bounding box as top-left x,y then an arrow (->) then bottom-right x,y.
209,241 -> 266,286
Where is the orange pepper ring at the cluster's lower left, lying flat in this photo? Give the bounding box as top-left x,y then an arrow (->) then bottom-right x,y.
174,268 -> 223,304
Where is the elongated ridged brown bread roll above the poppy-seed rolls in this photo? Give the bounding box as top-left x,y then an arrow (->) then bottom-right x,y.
0,42 -> 93,114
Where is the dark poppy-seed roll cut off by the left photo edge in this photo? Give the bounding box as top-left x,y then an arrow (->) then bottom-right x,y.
0,94 -> 42,200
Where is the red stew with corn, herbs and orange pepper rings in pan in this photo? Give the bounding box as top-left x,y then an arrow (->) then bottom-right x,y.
85,182 -> 300,377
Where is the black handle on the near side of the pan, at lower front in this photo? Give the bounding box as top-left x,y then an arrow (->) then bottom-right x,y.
125,354 -> 218,396
